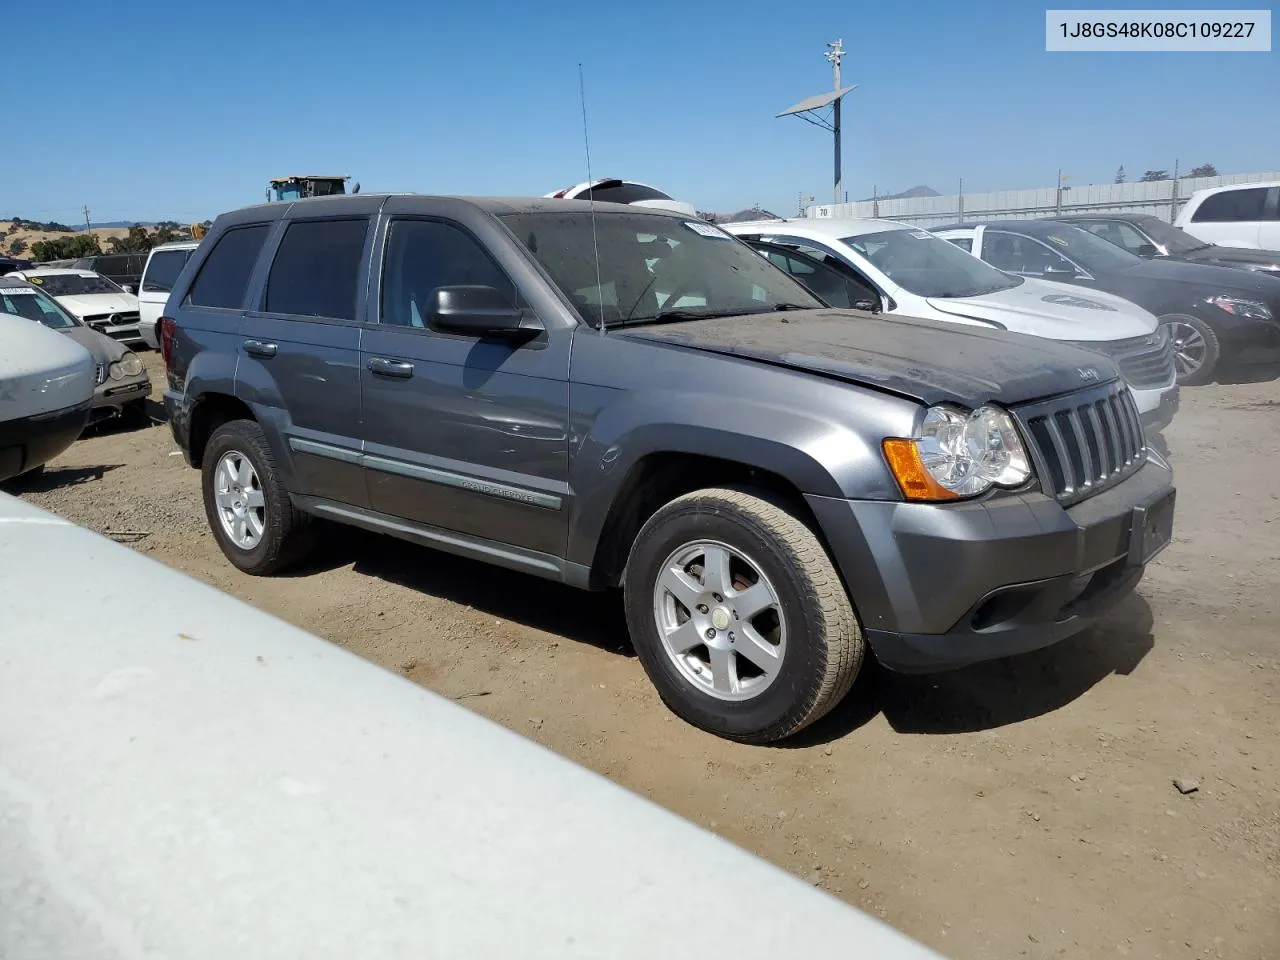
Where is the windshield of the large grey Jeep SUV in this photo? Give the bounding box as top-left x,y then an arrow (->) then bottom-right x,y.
500,211 -> 823,326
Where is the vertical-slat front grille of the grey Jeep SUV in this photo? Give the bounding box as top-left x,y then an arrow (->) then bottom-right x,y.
1014,383 -> 1147,504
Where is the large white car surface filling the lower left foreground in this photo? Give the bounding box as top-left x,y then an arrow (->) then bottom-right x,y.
0,496 -> 938,960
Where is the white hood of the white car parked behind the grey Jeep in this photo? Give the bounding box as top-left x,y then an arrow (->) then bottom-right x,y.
928,278 -> 1157,340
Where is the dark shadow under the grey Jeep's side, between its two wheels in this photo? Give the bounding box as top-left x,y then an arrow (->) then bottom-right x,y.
300,525 -> 635,657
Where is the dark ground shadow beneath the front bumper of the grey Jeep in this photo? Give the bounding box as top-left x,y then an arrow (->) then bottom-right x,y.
782,594 -> 1155,746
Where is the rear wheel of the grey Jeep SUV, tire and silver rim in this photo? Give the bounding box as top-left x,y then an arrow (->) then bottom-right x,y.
201,420 -> 311,576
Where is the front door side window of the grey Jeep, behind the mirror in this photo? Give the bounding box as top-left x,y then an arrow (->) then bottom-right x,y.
381,220 -> 517,328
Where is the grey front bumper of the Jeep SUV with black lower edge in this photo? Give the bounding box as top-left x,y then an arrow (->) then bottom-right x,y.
805,460 -> 1174,672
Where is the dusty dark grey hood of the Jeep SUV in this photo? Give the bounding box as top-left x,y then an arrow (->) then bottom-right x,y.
611,310 -> 1119,407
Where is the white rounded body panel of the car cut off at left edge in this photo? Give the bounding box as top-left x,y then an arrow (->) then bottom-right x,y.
0,314 -> 93,419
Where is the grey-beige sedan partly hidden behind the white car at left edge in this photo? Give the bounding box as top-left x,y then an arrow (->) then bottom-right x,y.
0,276 -> 151,422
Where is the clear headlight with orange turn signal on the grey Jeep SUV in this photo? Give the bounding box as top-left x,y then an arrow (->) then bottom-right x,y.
884,406 -> 1032,500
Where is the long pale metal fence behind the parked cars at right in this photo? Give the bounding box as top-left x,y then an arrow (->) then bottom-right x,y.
805,172 -> 1280,227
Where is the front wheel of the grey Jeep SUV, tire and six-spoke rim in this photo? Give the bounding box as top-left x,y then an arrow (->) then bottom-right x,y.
623,489 -> 865,744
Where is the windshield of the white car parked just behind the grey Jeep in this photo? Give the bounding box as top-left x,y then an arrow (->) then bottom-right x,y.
842,229 -> 1023,297
